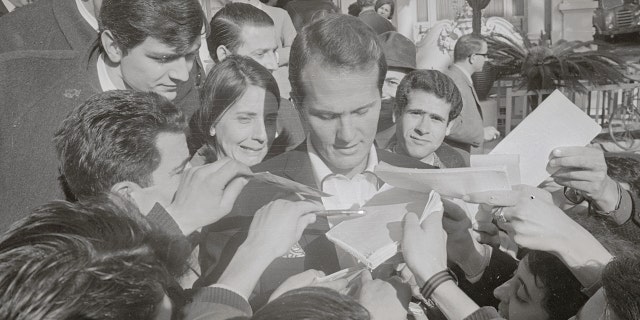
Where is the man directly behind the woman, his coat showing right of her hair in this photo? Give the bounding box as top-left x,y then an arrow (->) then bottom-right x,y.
206,3 -> 305,157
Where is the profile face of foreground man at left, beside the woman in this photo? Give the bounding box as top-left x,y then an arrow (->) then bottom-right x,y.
151,132 -> 189,192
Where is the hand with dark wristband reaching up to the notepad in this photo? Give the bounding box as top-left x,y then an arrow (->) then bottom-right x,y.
402,212 -> 447,284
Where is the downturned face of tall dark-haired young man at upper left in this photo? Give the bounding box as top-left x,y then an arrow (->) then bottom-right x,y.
120,37 -> 200,100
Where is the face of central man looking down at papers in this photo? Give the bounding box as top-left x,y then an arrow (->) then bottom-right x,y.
301,59 -> 380,174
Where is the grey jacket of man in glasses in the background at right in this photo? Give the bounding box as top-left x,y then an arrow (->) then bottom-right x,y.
445,64 -> 484,152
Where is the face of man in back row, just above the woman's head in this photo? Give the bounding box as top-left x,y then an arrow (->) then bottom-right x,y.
235,25 -> 278,72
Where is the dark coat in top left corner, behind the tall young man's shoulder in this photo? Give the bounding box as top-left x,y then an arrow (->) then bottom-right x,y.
0,0 -> 98,53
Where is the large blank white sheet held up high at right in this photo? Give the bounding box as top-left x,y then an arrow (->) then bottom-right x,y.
490,90 -> 601,186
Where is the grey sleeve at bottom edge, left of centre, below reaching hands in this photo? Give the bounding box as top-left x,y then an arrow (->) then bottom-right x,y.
182,286 -> 253,320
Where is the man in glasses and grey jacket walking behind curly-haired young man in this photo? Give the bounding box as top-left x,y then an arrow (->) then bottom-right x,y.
445,34 -> 500,158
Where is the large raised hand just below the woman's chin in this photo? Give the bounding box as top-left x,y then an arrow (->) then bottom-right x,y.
165,158 -> 252,235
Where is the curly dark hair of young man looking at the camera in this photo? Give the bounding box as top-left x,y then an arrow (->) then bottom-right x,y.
396,70 -> 462,122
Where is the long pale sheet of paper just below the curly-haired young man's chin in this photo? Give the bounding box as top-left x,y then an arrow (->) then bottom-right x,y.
375,163 -> 511,198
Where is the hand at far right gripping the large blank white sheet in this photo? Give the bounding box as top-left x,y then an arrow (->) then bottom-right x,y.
549,147 -> 619,211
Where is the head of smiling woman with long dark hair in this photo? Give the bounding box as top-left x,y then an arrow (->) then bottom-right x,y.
189,56 -> 280,166
